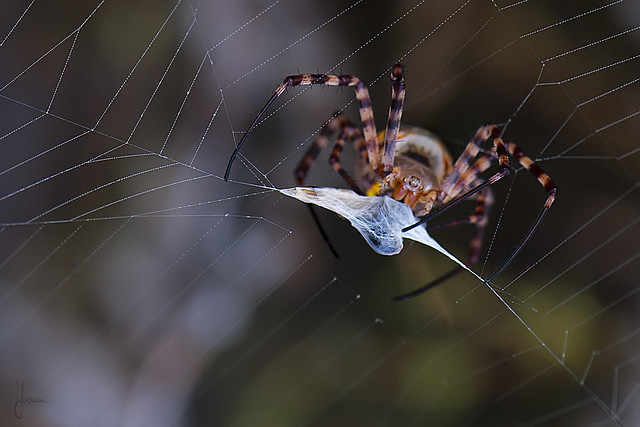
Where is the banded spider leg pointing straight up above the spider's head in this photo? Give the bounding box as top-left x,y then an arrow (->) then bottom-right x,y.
381,64 -> 406,175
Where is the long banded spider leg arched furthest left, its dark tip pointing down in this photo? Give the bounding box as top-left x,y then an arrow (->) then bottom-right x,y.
224,74 -> 380,181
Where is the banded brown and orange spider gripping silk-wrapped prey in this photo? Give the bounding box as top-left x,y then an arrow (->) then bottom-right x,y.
224,64 -> 557,299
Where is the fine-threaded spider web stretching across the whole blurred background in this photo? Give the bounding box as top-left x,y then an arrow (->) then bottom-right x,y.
0,0 -> 640,426
